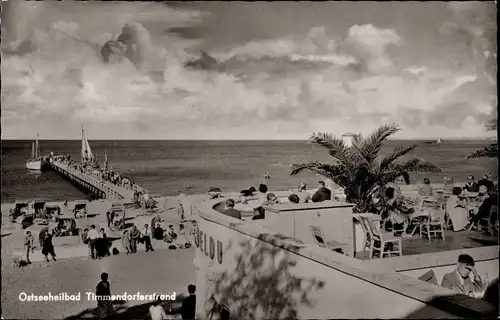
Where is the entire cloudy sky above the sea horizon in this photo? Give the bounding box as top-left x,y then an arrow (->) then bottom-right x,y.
1,1 -> 496,139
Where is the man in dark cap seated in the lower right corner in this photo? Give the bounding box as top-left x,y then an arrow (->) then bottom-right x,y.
441,254 -> 484,296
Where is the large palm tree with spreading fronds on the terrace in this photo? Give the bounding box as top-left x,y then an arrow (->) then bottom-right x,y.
291,124 -> 441,212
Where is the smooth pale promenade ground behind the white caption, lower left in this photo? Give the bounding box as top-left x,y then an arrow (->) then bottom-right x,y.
1,249 -> 196,319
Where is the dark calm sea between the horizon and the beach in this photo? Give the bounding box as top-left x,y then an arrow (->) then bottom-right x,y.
1,140 -> 497,203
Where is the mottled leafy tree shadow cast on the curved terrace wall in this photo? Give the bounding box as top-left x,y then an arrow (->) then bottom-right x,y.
210,235 -> 324,320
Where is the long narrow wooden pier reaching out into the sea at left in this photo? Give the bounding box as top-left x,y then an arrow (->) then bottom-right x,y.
50,159 -> 140,201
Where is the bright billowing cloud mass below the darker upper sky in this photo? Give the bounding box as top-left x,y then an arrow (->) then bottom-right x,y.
2,1 -> 492,139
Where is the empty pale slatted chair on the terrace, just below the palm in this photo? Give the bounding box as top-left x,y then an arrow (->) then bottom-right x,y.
360,217 -> 403,259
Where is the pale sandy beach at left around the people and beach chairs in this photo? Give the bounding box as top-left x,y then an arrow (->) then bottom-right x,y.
2,195 -> 207,319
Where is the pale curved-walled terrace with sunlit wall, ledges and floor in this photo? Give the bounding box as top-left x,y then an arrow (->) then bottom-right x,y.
197,186 -> 499,318
